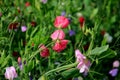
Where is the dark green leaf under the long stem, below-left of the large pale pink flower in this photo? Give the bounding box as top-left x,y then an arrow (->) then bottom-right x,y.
61,68 -> 79,79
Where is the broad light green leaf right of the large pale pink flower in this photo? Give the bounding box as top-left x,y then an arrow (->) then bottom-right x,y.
90,45 -> 109,55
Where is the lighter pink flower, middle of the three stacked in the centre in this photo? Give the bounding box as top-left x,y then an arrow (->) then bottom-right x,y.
51,30 -> 65,40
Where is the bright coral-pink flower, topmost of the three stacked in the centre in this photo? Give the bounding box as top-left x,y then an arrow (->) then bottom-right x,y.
54,16 -> 69,28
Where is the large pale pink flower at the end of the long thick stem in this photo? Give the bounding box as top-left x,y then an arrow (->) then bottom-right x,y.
75,49 -> 91,73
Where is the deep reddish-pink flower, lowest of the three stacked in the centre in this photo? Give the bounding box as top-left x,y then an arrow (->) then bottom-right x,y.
53,40 -> 68,52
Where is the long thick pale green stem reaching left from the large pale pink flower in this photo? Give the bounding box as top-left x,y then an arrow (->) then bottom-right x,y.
44,62 -> 78,75
